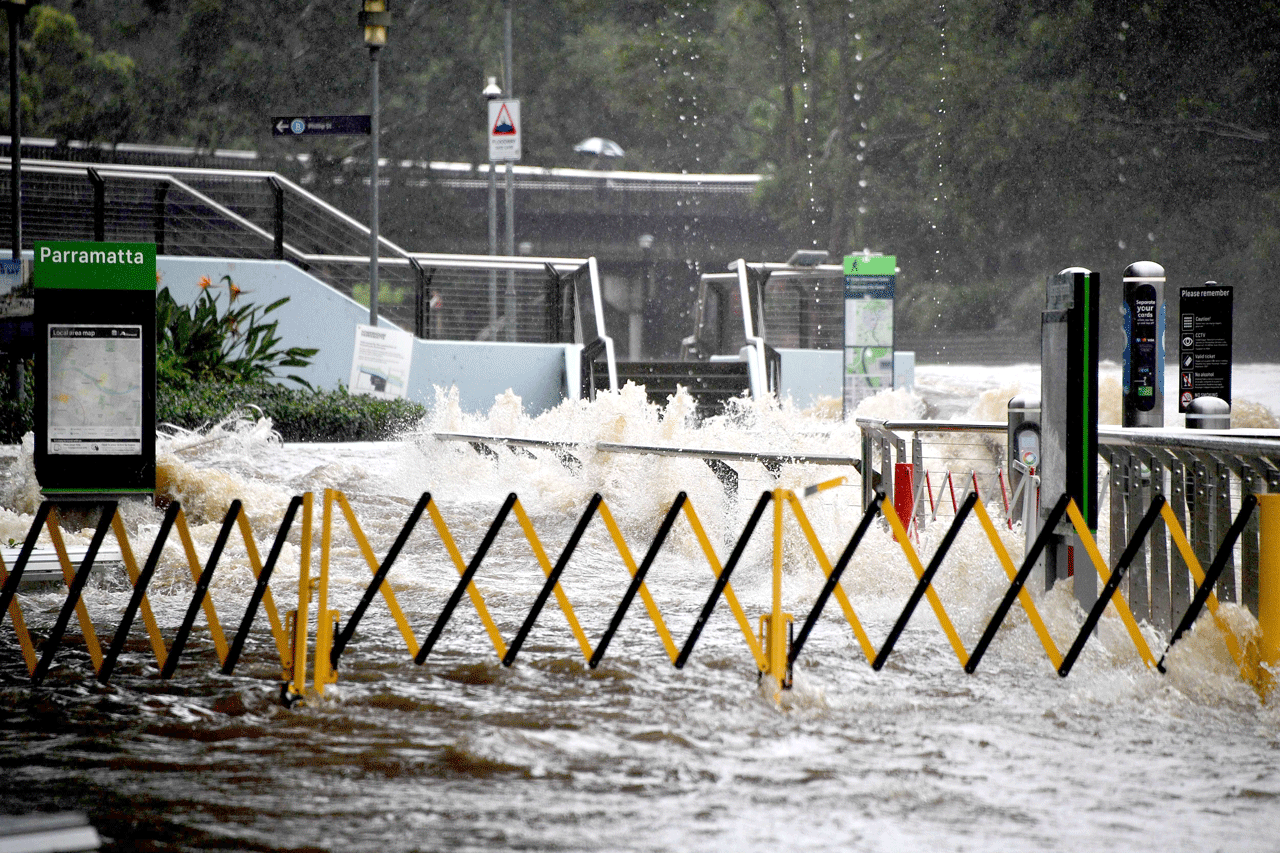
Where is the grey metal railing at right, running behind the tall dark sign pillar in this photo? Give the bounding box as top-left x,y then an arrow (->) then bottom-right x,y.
858,418 -> 1280,629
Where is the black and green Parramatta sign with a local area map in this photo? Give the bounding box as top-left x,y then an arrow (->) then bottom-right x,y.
32,242 -> 156,501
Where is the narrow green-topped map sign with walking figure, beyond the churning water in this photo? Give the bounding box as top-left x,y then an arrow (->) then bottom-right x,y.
844,255 -> 897,416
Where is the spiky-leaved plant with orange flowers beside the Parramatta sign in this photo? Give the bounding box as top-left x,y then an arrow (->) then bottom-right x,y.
156,275 -> 317,387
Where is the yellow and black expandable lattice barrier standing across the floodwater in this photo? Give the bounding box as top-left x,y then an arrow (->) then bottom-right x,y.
0,479 -> 1280,703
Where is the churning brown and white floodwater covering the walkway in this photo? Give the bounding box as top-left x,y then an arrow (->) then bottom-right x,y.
0,365 -> 1280,853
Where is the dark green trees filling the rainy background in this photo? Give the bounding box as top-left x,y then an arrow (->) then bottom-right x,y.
15,0 -> 1280,357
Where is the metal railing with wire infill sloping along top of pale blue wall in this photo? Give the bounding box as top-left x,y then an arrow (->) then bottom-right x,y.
0,161 -> 612,352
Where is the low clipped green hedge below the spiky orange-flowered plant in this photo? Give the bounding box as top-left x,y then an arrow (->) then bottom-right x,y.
156,382 -> 426,442
